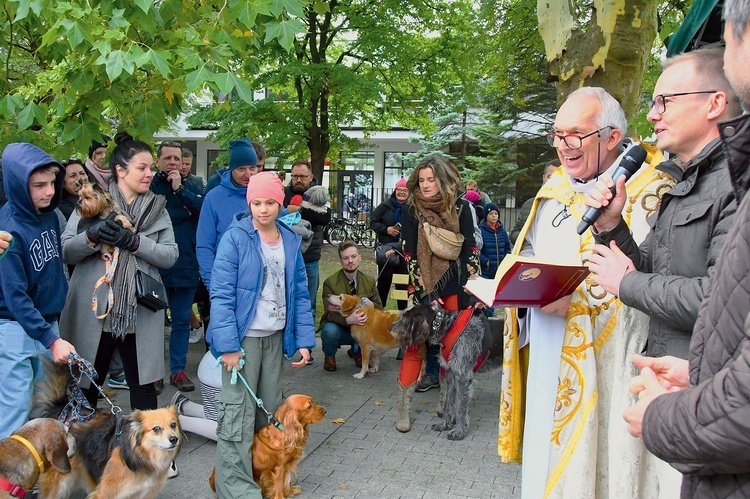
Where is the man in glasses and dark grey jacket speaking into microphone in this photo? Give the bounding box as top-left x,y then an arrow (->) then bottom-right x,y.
587,48 -> 740,496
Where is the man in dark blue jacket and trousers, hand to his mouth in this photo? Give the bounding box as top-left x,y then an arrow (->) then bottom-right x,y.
151,142 -> 203,392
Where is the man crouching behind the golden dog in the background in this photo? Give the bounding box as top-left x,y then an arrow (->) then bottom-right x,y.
320,241 -> 383,372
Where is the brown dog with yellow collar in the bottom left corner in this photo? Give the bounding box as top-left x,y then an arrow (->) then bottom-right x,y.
0,418 -> 70,498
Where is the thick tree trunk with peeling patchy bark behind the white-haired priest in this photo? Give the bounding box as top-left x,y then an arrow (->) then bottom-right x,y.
537,0 -> 657,122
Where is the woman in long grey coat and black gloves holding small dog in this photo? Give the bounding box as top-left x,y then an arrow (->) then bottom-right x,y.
60,132 -> 177,410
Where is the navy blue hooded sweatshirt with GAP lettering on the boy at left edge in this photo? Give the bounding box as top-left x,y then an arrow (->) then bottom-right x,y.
0,143 -> 68,347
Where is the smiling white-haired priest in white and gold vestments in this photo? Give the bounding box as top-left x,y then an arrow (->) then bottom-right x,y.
498,87 -> 671,497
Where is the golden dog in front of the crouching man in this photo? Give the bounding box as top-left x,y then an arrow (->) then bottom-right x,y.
328,295 -> 398,379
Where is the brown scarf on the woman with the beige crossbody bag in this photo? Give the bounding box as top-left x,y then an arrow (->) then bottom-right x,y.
412,190 -> 460,294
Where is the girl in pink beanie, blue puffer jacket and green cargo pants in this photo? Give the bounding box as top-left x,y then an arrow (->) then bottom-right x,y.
207,172 -> 315,498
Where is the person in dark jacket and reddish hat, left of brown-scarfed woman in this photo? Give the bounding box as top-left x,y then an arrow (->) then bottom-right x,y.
370,178 -> 409,310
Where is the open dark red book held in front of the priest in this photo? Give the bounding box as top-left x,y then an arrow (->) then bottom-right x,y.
464,255 -> 589,307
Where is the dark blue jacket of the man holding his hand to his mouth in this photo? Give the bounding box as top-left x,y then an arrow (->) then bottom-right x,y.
151,172 -> 203,288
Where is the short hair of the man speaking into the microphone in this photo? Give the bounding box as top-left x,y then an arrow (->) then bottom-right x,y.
661,47 -> 742,118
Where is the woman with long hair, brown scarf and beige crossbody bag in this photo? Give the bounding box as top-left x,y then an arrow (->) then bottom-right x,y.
396,156 -> 479,432
